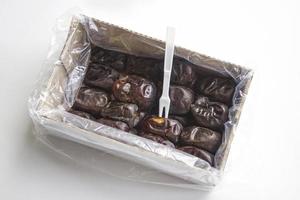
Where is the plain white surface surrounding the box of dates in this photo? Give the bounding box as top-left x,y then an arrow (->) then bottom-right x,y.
0,0 -> 300,200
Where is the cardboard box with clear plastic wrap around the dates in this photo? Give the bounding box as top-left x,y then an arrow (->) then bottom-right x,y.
29,15 -> 253,189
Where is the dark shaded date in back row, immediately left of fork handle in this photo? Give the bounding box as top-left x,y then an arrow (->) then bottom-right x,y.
126,56 -> 163,82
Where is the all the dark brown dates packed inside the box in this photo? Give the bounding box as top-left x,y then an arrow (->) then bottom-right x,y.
70,46 -> 236,166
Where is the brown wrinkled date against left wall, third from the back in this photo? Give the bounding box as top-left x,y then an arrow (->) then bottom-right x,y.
72,87 -> 110,116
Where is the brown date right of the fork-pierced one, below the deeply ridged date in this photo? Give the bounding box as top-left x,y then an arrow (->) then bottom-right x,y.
180,126 -> 222,153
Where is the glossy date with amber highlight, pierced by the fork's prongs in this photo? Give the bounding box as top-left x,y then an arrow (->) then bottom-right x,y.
142,116 -> 183,143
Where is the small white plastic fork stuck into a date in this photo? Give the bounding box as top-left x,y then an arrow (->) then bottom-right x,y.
159,27 -> 175,118
